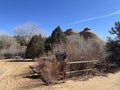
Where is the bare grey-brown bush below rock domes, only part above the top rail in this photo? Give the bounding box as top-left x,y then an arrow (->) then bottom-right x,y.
66,35 -> 106,61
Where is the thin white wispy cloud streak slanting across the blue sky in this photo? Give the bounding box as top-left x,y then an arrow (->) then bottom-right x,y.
68,10 -> 120,25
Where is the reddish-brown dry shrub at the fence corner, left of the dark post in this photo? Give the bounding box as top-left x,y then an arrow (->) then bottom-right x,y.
36,52 -> 58,82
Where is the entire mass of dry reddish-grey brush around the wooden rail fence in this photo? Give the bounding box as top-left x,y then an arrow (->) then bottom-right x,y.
30,35 -> 107,85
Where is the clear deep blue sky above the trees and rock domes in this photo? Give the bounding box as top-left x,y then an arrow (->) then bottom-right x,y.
0,0 -> 120,39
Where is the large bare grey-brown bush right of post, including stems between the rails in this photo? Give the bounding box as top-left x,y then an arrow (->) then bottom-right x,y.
65,35 -> 106,76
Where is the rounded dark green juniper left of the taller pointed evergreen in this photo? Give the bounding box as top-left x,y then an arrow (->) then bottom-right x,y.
25,35 -> 44,58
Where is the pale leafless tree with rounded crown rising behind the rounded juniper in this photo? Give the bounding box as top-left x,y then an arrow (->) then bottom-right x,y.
15,23 -> 42,46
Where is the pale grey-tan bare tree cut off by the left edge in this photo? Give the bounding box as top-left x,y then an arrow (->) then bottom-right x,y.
0,34 -> 21,58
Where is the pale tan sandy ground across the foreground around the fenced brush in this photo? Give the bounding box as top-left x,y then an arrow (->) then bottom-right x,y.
0,60 -> 120,90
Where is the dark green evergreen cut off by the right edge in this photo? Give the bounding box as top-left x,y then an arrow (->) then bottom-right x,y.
107,22 -> 120,66
